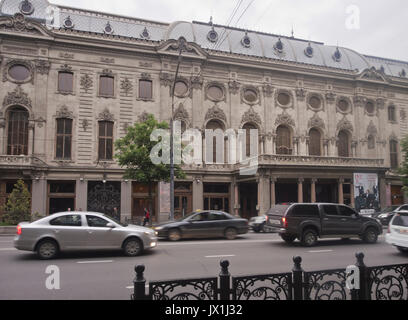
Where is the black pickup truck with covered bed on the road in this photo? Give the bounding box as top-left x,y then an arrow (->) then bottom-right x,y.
265,203 -> 383,247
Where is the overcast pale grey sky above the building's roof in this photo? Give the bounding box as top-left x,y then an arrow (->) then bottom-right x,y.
50,0 -> 408,61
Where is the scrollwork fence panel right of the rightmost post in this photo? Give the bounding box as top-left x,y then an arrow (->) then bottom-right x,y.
369,265 -> 408,300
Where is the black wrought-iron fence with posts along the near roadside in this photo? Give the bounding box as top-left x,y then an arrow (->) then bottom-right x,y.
132,253 -> 408,301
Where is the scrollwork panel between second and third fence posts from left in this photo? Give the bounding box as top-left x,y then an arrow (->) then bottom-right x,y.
232,273 -> 292,300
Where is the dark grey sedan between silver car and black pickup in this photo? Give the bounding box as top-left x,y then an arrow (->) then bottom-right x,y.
154,211 -> 249,241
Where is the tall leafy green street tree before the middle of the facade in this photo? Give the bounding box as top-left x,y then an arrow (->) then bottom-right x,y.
115,115 -> 185,220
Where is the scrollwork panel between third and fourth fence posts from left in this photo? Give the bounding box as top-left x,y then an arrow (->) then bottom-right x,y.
305,270 -> 351,300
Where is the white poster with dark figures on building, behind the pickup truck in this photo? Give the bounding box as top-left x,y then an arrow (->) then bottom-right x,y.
354,173 -> 380,215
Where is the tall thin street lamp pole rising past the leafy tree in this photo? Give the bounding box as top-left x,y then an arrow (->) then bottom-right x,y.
170,37 -> 186,221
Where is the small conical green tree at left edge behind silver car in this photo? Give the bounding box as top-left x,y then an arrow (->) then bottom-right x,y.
2,180 -> 31,225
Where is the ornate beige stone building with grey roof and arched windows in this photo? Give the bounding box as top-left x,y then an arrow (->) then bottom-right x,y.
0,0 -> 408,220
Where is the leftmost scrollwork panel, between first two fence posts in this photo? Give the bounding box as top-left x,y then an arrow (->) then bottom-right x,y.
149,278 -> 217,301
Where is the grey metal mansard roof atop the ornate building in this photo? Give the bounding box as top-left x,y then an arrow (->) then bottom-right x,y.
0,0 -> 408,78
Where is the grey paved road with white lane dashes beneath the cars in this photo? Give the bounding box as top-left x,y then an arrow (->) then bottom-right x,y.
0,233 -> 408,300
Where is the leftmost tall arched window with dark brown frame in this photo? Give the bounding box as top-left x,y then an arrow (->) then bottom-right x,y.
7,107 -> 29,156
